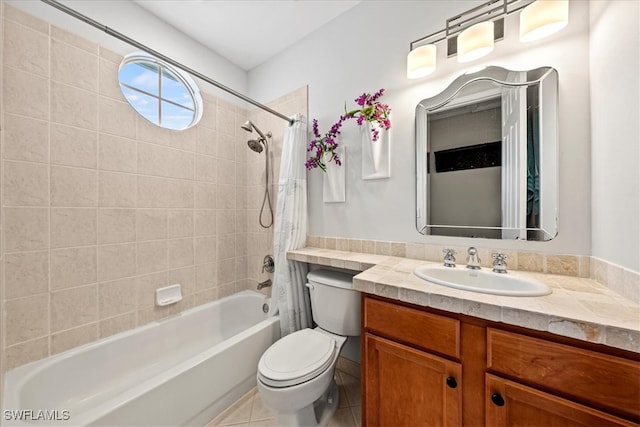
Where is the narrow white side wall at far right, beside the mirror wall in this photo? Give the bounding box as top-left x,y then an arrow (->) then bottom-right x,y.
589,1 -> 640,271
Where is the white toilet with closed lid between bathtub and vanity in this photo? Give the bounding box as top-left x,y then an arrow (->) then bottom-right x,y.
258,270 -> 360,426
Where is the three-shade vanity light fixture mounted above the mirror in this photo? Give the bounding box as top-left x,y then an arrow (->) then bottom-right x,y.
407,0 -> 569,79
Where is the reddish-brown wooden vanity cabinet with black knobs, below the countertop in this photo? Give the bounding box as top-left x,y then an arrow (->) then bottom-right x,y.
362,295 -> 640,427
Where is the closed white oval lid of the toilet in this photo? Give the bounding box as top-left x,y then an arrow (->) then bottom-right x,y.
258,329 -> 336,387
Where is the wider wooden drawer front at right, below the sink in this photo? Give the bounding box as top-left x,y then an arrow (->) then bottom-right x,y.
487,328 -> 640,419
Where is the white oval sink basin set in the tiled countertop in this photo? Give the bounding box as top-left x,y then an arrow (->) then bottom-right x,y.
413,265 -> 551,297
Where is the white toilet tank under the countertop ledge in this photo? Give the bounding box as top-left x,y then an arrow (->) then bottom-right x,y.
307,269 -> 360,336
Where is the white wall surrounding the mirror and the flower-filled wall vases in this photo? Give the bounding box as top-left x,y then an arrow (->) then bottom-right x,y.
249,1 -> 591,255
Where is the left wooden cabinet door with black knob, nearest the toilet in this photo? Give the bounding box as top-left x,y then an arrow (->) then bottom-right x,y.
364,333 -> 462,427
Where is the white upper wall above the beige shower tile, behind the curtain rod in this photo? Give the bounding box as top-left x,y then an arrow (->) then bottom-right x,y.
6,0 -> 251,108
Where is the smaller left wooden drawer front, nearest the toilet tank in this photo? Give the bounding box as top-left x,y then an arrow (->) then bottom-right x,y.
364,298 -> 460,358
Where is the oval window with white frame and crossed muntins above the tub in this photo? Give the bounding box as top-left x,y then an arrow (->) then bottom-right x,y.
118,53 -> 202,130
